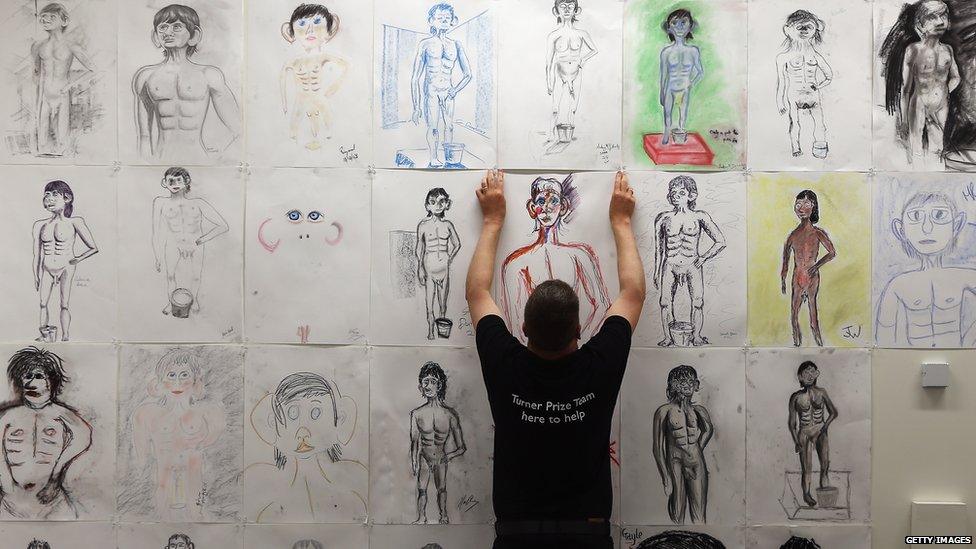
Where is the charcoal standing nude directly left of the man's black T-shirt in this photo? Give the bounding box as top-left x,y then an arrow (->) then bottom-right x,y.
410,362 -> 468,524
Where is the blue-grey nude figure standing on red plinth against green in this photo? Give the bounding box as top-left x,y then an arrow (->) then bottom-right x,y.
660,9 -> 705,145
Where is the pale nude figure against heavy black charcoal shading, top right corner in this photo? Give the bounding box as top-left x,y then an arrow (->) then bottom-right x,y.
879,0 -> 962,163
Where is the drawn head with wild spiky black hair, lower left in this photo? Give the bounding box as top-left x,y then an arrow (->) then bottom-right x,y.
7,346 -> 68,408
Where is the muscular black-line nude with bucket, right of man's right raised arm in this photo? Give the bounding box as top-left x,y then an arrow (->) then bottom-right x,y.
654,175 -> 725,347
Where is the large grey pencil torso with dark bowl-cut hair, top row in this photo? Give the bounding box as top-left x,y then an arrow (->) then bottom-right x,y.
132,4 -> 241,161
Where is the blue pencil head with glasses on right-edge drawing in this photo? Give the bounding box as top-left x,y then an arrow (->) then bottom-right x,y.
891,192 -> 966,259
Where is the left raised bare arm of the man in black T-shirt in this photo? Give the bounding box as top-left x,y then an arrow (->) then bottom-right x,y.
464,170 -> 505,327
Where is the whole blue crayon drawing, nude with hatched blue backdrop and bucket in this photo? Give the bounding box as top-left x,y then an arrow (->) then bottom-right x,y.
380,3 -> 494,169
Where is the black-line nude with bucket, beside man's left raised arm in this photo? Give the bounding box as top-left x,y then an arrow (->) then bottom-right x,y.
414,187 -> 461,339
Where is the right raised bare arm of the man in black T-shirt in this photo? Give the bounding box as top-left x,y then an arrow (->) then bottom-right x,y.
607,172 -> 647,330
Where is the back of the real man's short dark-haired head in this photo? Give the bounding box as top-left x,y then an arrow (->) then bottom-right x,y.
522,279 -> 580,353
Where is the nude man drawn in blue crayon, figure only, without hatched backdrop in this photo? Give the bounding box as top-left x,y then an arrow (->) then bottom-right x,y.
410,3 -> 471,168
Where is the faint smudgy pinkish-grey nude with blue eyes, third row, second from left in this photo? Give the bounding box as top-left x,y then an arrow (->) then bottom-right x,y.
132,349 -> 226,520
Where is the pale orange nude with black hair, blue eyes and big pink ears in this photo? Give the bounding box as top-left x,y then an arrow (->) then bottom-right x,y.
281,4 -> 349,151
